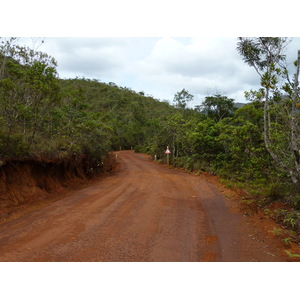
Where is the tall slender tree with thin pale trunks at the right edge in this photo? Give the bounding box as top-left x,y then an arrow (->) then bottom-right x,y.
237,37 -> 300,185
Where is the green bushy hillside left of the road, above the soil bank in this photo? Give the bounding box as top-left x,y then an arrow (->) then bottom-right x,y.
0,39 -> 178,165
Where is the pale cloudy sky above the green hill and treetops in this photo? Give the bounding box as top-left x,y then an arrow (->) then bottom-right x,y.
20,37 -> 300,106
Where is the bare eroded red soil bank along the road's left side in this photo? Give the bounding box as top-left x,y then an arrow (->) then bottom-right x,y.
0,155 -> 115,223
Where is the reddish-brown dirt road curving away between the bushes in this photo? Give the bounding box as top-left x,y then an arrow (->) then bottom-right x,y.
0,151 -> 283,262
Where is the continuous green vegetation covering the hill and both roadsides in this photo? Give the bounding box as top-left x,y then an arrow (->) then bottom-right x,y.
0,40 -> 300,239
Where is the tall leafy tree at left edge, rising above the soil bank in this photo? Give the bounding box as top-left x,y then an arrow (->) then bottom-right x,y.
0,38 -> 59,155
